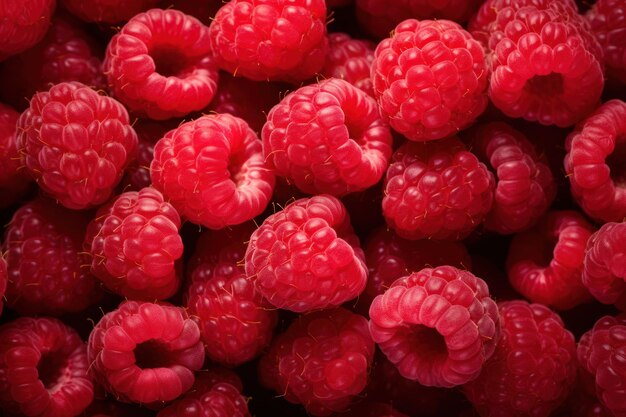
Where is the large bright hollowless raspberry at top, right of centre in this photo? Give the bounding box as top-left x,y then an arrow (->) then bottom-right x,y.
371,19 -> 489,141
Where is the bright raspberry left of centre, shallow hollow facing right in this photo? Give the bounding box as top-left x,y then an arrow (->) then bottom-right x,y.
150,114 -> 274,229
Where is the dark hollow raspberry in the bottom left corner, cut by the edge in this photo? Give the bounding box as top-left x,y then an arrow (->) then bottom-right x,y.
0,317 -> 94,417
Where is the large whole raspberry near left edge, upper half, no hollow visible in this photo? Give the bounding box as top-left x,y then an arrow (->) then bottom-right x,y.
17,82 -> 137,209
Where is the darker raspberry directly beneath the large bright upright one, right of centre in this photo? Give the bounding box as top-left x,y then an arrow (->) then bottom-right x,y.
383,138 -> 495,240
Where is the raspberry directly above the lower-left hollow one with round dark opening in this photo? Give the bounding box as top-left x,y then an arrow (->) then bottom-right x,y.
85,188 -> 183,301
